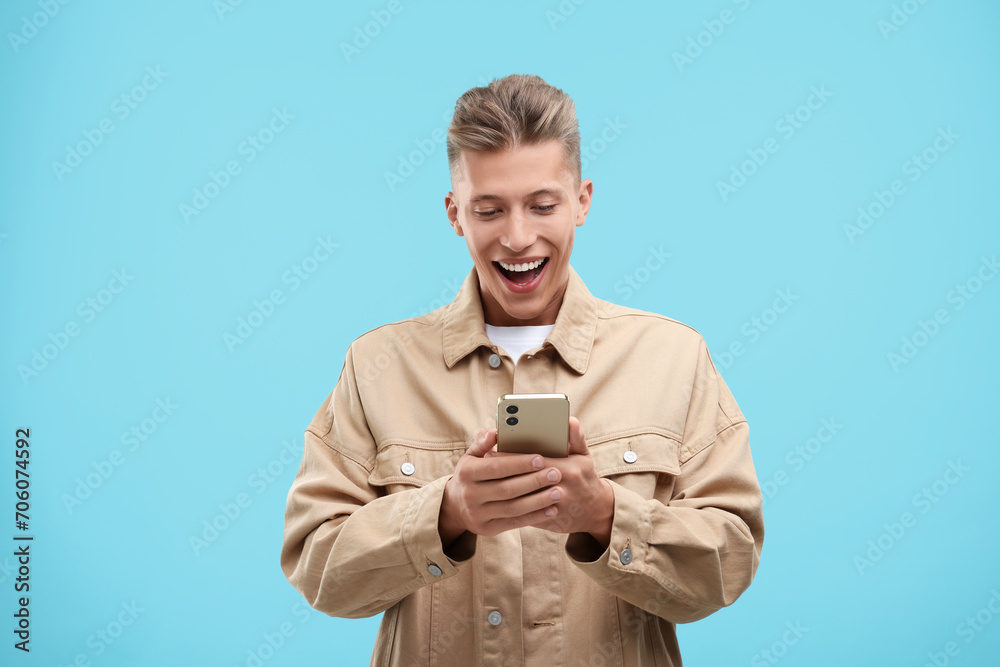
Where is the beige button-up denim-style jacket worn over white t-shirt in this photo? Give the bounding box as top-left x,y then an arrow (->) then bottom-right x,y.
281,269 -> 764,667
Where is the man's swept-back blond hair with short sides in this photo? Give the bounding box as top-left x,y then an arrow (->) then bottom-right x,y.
447,74 -> 582,181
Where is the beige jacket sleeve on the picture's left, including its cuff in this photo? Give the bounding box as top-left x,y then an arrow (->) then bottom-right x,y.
281,348 -> 475,618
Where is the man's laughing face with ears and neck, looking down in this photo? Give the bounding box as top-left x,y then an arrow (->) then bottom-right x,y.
444,140 -> 594,326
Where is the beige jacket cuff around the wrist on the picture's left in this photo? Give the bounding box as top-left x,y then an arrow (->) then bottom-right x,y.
401,475 -> 476,584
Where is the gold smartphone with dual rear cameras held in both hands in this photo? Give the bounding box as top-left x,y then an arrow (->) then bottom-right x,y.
497,394 -> 569,457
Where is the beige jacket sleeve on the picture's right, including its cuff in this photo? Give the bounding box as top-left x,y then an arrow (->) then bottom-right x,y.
566,340 -> 764,623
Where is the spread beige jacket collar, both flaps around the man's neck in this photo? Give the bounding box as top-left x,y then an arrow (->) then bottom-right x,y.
443,266 -> 597,375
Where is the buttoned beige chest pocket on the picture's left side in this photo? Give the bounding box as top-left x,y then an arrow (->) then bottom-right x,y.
368,441 -> 468,493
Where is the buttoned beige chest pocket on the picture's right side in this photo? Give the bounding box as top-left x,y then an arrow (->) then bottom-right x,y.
589,431 -> 681,502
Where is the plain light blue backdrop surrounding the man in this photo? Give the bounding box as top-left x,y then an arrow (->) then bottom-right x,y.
0,0 -> 1000,666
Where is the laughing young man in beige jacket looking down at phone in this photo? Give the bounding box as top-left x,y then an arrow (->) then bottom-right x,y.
281,75 -> 764,666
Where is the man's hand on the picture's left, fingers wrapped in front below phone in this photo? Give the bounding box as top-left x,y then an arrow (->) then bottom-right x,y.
438,428 -> 563,547
